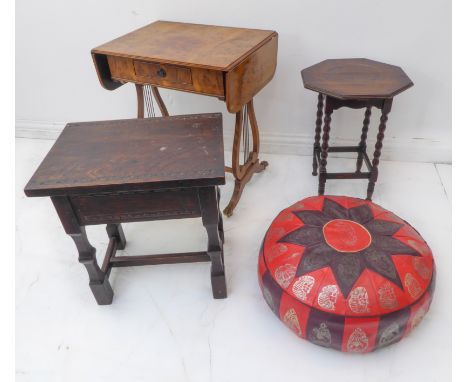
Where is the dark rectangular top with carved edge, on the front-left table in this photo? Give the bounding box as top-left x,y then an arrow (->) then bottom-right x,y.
25,113 -> 224,196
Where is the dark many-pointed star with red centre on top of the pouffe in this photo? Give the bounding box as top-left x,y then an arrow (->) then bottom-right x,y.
278,198 -> 421,298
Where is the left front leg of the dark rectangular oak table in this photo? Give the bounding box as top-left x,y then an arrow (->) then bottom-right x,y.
51,196 -> 114,305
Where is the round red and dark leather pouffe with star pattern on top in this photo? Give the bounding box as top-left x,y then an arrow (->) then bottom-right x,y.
258,196 -> 435,353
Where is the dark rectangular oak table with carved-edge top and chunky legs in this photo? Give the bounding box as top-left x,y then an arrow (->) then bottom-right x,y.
24,113 -> 226,305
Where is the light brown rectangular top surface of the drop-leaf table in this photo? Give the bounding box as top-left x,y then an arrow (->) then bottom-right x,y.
92,21 -> 276,71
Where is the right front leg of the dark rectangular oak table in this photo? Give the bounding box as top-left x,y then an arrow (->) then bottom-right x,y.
199,187 -> 227,298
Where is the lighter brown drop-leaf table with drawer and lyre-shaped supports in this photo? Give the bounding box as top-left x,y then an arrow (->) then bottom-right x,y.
91,21 -> 278,216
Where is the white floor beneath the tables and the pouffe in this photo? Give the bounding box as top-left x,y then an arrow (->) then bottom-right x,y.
16,139 -> 452,382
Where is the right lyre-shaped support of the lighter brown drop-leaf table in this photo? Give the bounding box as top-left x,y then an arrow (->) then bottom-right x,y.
224,100 -> 268,216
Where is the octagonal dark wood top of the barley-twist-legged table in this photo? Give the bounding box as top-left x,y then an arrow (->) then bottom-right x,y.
301,58 -> 413,99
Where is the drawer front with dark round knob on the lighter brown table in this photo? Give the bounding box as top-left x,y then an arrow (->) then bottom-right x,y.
107,56 -> 224,98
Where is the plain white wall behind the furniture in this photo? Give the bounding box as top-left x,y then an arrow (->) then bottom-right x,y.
16,0 -> 451,162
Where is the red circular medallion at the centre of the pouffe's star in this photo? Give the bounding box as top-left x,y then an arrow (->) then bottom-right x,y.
323,219 -> 372,252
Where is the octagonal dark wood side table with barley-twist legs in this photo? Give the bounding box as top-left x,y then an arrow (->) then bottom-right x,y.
301,58 -> 413,200
